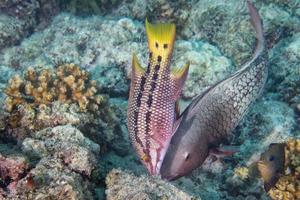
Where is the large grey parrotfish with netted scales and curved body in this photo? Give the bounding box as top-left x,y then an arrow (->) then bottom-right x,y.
160,1 -> 268,181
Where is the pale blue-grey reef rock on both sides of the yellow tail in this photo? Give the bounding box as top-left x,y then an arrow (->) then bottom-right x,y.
0,14 -> 234,98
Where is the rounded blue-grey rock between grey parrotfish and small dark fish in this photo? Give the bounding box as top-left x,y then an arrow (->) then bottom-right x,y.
235,100 -> 296,163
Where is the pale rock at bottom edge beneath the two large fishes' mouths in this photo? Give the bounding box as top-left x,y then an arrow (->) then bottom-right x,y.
106,169 -> 199,200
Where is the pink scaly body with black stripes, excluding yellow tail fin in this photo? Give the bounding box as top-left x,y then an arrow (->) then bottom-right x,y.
127,53 -> 179,174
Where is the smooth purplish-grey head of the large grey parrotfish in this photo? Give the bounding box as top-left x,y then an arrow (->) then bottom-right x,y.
160,116 -> 208,181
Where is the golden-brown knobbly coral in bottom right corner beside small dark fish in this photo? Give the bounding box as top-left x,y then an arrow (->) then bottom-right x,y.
269,139 -> 300,200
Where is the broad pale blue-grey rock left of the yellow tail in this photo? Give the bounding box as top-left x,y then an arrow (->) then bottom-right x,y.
0,14 -> 146,95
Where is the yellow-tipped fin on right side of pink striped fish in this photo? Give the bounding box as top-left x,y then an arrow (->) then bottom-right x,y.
171,62 -> 190,101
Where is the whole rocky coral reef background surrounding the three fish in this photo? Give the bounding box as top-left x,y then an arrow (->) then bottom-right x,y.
0,0 -> 300,200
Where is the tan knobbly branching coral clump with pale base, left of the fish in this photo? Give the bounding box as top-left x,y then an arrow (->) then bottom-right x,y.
4,64 -> 107,134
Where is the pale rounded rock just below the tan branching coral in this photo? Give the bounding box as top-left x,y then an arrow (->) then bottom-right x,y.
22,125 -> 100,176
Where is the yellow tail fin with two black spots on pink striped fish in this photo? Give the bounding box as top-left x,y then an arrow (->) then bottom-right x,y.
145,19 -> 176,59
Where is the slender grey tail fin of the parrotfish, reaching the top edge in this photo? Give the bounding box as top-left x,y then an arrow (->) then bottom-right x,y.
247,0 -> 265,57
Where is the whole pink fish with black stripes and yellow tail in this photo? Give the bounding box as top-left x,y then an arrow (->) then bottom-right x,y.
127,19 -> 189,175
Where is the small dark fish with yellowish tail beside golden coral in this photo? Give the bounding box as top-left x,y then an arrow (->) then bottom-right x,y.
249,143 -> 286,192
